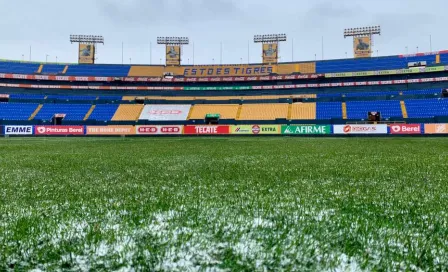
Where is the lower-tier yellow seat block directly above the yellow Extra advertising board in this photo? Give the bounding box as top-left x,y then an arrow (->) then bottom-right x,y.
239,103 -> 288,120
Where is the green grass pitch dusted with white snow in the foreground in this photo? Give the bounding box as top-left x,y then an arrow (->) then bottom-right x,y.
0,137 -> 448,271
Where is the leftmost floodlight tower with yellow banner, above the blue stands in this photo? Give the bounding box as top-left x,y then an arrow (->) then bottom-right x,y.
70,35 -> 104,64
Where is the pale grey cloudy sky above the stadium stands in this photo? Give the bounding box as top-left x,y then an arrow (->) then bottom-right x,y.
0,0 -> 448,64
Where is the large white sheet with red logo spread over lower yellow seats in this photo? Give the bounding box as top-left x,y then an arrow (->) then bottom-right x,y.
139,105 -> 191,121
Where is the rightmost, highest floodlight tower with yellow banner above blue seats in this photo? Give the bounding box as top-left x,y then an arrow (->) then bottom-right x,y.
344,26 -> 381,57
